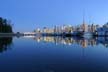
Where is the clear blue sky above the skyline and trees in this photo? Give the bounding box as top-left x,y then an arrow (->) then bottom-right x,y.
0,0 -> 108,32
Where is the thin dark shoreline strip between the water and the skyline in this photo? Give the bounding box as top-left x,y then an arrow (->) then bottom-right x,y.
0,33 -> 108,37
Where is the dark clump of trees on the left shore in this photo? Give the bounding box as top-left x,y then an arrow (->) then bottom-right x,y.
0,17 -> 13,33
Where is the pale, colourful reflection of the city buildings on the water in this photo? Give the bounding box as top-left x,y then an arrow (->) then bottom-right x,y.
33,37 -> 108,48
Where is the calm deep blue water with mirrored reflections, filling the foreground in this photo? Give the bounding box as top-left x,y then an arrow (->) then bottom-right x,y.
0,37 -> 108,72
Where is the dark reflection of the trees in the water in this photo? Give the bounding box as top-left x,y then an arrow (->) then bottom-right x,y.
0,37 -> 13,53
